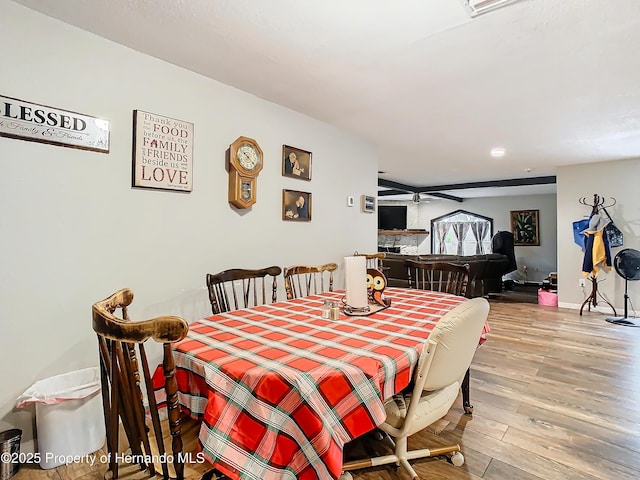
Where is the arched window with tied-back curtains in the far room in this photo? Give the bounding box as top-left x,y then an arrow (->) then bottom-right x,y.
431,210 -> 493,255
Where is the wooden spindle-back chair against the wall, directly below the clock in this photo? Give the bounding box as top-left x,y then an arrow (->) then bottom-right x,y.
207,266 -> 282,315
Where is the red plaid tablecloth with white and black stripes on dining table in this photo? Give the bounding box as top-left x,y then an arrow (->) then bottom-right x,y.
170,288 -> 476,480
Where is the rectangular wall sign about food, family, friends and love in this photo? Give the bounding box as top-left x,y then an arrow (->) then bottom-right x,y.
133,110 -> 193,192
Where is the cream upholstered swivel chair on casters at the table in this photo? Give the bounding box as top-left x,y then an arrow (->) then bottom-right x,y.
341,298 -> 489,480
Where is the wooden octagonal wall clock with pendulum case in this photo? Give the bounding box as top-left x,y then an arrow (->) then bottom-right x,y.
229,137 -> 263,208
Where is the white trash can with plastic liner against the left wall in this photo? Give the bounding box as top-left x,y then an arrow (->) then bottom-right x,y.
16,367 -> 106,469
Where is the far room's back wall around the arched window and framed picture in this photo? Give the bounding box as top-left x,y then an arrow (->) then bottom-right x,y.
392,195 -> 557,282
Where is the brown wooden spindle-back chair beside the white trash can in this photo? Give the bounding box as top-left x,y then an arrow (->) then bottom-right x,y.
92,288 -> 217,480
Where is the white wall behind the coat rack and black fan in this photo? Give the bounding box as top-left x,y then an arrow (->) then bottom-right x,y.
557,159 -> 640,316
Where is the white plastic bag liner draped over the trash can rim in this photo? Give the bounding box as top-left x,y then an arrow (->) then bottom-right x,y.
16,367 -> 101,408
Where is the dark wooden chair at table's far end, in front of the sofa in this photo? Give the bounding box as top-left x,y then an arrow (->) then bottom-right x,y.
404,260 -> 473,415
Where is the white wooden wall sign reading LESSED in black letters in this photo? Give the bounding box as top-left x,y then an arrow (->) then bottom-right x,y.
0,95 -> 109,153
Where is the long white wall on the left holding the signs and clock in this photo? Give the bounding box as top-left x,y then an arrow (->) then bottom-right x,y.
0,2 -> 377,440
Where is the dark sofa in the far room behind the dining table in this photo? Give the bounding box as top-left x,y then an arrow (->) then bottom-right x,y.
382,253 -> 509,298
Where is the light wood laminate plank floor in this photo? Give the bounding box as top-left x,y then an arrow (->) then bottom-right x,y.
13,301 -> 640,480
